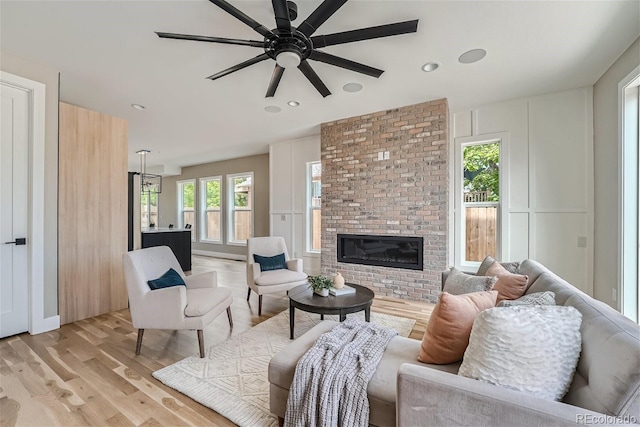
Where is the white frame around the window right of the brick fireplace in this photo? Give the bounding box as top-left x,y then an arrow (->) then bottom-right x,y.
453,132 -> 509,273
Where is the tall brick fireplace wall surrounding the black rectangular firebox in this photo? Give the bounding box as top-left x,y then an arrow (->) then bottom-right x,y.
321,99 -> 449,302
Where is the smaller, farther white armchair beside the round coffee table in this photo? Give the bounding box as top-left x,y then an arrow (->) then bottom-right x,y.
247,237 -> 307,316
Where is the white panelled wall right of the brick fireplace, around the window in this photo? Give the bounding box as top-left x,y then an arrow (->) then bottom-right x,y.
450,87 -> 594,295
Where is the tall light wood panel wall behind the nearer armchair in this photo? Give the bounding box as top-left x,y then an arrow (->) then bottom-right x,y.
58,103 -> 127,324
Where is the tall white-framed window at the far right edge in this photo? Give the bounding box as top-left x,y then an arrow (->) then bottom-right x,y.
614,66 -> 640,323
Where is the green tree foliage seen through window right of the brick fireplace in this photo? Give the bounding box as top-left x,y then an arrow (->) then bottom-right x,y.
463,142 -> 500,202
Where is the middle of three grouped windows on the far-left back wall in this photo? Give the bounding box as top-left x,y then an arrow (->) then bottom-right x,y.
200,176 -> 222,243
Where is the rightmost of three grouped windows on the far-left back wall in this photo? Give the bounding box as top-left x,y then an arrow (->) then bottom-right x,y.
227,172 -> 253,245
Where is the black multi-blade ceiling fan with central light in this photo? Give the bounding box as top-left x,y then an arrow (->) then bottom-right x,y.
156,0 -> 418,98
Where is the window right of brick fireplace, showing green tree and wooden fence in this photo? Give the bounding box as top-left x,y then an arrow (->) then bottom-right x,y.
455,140 -> 501,269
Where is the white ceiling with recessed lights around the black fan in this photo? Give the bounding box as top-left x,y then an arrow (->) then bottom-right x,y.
0,0 -> 640,170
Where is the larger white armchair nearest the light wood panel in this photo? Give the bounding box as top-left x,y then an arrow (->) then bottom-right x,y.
122,246 -> 233,357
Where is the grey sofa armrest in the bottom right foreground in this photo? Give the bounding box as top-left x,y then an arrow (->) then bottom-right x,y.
396,364 -> 604,427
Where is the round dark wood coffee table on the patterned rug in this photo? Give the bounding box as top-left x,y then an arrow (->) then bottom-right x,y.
289,283 -> 374,339
